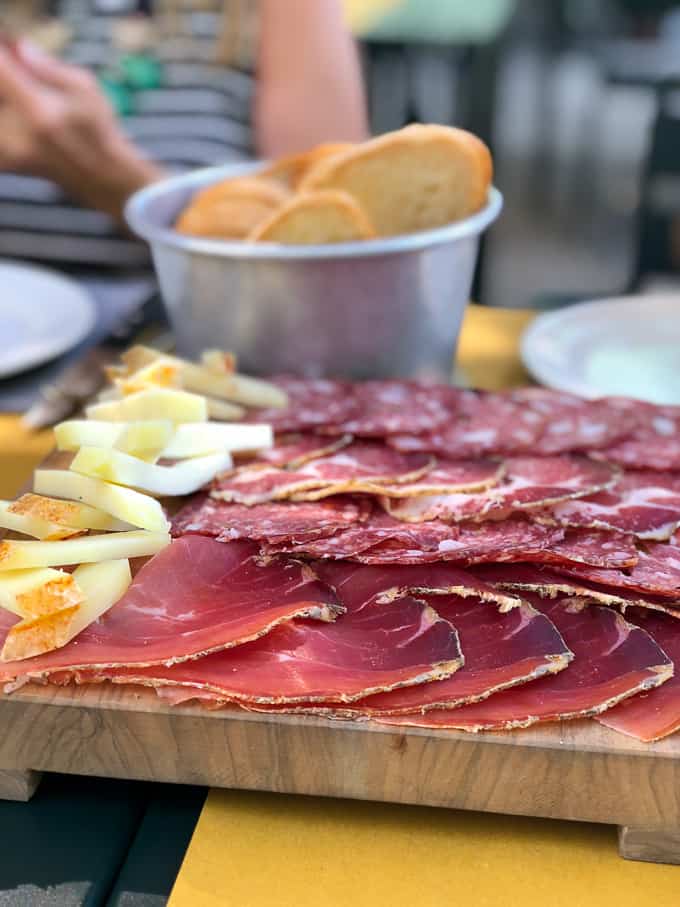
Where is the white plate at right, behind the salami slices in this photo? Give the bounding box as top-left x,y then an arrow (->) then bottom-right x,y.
521,294 -> 680,404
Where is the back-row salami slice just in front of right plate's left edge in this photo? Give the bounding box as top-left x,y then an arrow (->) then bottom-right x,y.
510,387 -> 639,454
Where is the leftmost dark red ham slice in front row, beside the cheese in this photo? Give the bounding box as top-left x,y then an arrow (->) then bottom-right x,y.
0,536 -> 342,682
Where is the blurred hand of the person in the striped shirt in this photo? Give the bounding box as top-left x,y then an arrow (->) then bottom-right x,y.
0,42 -> 161,219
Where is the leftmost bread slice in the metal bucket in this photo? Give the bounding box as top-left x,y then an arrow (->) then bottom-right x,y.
175,177 -> 289,239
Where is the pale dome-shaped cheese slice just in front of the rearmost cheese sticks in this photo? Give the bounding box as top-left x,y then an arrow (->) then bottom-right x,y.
85,387 -> 208,422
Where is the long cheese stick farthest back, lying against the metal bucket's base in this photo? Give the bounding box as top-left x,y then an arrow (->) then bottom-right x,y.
122,345 -> 288,407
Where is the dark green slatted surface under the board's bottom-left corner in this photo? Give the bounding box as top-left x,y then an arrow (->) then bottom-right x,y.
0,775 -> 206,907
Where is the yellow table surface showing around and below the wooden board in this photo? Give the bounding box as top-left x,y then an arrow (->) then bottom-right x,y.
0,306 -> 680,907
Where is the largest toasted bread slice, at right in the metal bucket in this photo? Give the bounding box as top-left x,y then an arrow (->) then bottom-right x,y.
300,125 -> 492,236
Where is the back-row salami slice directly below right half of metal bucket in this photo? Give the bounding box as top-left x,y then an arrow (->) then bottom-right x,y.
324,381 -> 462,438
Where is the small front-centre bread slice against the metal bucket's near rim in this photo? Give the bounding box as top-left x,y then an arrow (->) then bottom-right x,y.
248,190 -> 375,245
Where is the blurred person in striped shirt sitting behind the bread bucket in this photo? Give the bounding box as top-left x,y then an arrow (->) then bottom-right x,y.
0,0 -> 368,266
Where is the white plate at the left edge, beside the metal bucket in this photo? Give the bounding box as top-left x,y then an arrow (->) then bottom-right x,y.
0,261 -> 95,378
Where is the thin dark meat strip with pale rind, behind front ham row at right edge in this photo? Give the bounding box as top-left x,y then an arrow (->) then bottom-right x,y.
474,564 -> 680,617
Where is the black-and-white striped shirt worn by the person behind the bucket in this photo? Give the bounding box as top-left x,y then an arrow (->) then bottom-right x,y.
0,0 -> 257,267
